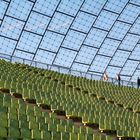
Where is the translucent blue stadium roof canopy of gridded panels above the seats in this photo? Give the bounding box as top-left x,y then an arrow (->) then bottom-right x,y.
0,0 -> 140,81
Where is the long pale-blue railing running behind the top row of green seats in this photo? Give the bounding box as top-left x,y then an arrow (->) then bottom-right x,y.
0,53 -> 137,87
